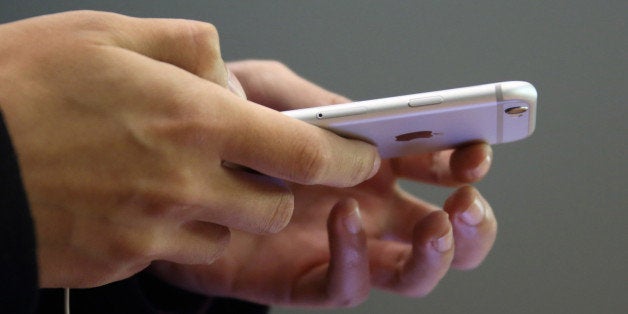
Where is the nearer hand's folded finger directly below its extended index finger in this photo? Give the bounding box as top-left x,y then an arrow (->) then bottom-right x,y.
136,162 -> 294,234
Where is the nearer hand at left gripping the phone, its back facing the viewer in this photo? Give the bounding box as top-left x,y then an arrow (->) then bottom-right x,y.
0,12 -> 379,287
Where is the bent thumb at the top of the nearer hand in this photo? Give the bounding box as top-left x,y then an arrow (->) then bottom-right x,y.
104,15 -> 228,87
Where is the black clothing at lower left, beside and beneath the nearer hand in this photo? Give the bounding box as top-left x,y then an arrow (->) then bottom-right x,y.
0,113 -> 268,314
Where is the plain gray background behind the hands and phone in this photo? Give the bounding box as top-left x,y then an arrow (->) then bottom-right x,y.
0,0 -> 628,314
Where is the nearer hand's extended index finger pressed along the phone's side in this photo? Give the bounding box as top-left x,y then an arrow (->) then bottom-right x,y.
222,93 -> 380,187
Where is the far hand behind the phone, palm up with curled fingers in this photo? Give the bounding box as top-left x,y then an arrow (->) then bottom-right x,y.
152,61 -> 497,307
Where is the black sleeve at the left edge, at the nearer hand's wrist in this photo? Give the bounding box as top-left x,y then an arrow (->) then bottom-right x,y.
0,112 -> 38,313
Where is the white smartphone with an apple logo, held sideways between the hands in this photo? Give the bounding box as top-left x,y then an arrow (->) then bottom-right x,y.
283,81 -> 537,158
